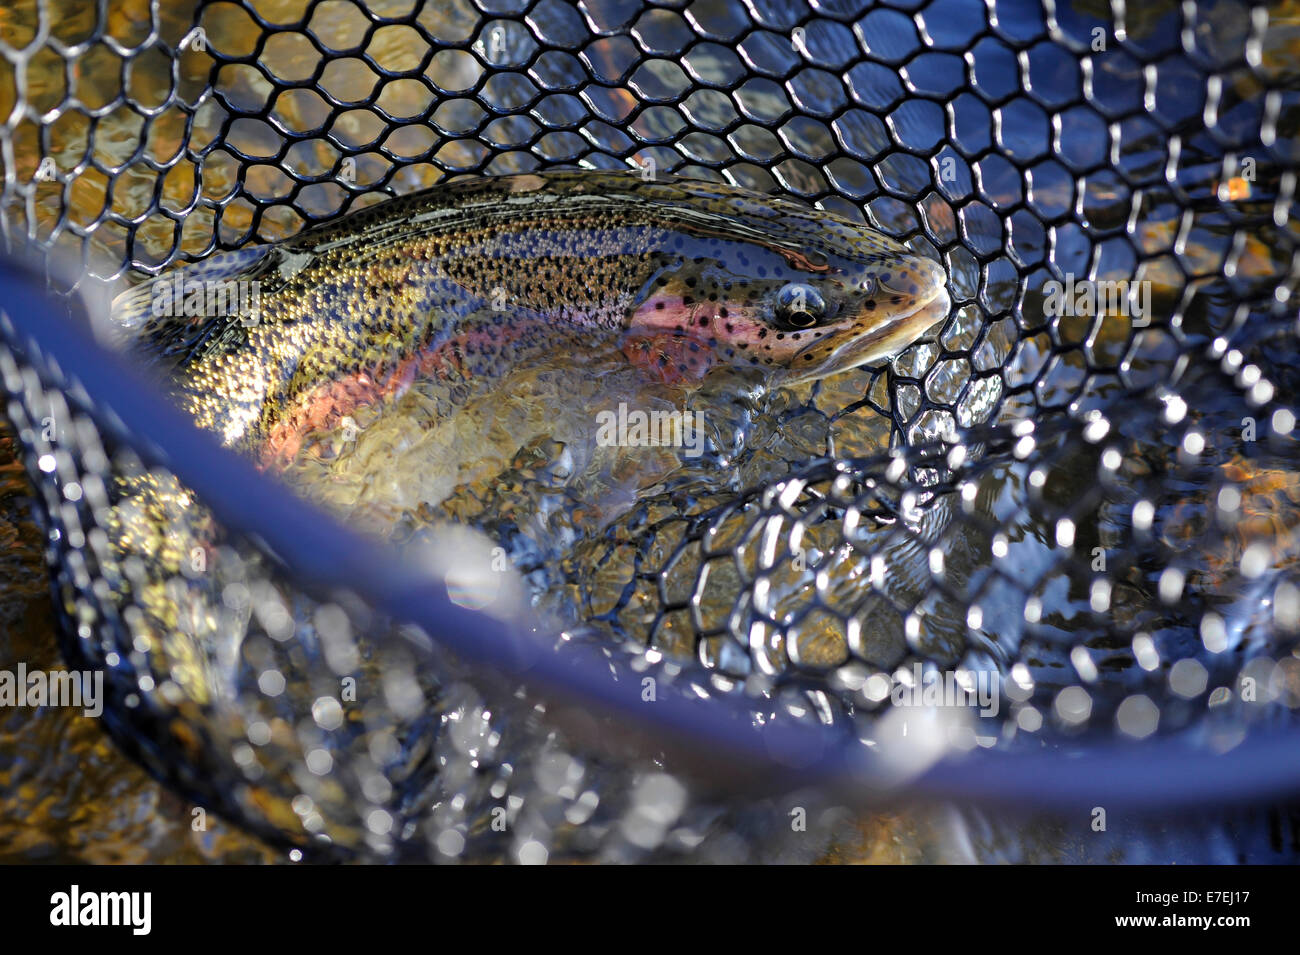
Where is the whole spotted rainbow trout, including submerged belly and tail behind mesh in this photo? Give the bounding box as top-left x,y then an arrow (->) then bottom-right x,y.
100,173 -> 949,753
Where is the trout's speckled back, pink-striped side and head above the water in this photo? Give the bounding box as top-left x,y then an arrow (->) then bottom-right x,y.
114,172 -> 949,485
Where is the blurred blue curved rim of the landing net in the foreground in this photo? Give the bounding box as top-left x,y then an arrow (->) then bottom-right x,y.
0,256 -> 1300,809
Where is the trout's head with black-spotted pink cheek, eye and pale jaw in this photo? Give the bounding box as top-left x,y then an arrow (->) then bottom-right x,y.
633,184 -> 950,383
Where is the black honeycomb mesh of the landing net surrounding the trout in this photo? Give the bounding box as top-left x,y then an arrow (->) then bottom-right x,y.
0,0 -> 1300,861
